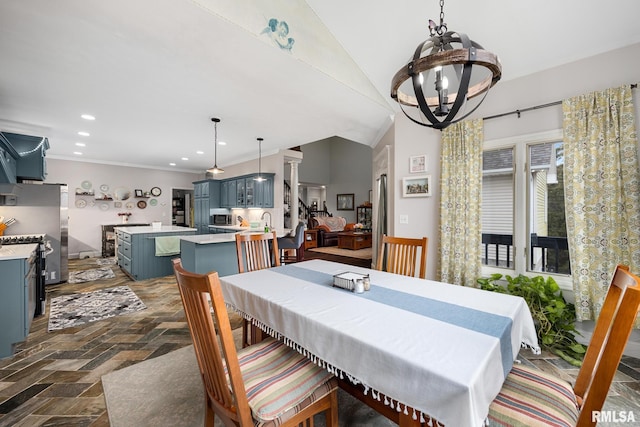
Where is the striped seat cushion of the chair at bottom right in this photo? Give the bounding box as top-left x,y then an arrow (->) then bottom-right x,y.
489,366 -> 579,427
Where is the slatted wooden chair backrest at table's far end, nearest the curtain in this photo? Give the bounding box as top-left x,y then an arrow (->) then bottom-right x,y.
376,234 -> 429,279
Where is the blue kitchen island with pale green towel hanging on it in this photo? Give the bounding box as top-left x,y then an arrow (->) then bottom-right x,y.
115,225 -> 197,280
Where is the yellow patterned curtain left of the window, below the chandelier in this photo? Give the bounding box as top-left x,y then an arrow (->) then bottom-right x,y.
438,119 -> 484,287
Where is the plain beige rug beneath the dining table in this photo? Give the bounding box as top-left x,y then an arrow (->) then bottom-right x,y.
102,342 -> 397,427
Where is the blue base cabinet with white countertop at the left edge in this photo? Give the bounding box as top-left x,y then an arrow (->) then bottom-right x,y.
0,243 -> 38,359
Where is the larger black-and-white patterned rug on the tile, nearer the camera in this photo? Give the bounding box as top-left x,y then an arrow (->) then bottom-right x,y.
48,286 -> 147,331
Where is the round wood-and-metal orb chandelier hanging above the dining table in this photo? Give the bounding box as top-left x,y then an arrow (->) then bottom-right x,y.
391,0 -> 502,130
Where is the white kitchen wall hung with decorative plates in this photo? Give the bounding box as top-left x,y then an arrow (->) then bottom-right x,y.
45,159 -> 202,258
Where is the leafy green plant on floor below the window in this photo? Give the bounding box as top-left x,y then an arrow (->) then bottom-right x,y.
477,273 -> 586,366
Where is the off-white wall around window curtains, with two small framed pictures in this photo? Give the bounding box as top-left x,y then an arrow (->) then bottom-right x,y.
384,43 -> 640,279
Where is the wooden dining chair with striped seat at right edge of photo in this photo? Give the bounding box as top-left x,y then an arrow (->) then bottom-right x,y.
489,265 -> 640,427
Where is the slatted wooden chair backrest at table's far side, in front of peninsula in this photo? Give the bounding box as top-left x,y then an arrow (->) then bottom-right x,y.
236,231 -> 280,273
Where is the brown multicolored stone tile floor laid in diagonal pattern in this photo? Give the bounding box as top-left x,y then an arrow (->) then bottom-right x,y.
0,258 -> 640,427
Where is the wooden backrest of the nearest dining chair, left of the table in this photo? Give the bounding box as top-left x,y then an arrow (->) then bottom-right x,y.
173,258 -> 253,426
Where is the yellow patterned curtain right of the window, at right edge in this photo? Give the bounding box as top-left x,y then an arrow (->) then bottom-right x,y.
562,86 -> 640,320
